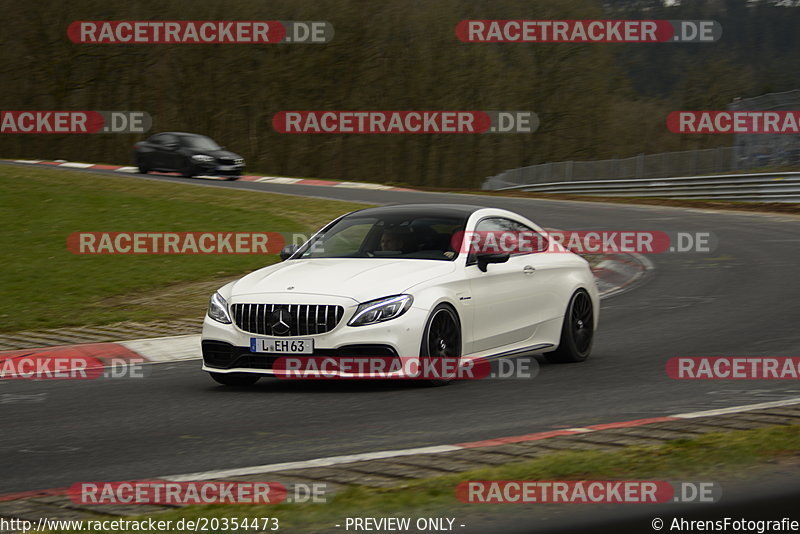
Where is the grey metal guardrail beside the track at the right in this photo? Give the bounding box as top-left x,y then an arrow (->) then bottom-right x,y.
488,172 -> 800,202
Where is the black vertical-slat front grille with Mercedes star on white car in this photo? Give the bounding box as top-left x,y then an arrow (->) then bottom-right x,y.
232,304 -> 344,337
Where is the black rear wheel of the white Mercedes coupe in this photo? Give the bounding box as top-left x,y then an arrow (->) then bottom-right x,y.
544,289 -> 594,363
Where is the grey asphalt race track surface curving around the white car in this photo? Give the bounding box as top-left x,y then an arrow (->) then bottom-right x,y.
0,163 -> 800,502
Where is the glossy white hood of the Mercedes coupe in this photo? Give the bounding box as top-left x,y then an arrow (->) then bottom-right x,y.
231,258 -> 455,302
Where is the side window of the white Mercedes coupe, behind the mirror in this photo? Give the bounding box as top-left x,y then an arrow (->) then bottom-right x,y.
468,217 -> 547,261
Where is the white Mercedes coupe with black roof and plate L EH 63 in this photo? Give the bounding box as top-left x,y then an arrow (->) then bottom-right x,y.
202,204 -> 599,386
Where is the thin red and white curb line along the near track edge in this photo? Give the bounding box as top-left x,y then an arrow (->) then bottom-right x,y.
0,397 -> 800,502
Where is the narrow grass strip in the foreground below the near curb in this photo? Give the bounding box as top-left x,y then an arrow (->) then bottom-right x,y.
51,425 -> 800,532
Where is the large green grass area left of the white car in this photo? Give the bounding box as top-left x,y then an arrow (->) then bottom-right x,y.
0,166 -> 365,332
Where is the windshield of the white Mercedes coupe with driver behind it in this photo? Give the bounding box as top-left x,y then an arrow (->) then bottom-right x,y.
299,213 -> 466,261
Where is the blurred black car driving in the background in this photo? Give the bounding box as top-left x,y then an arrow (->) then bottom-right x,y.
133,132 -> 244,180
